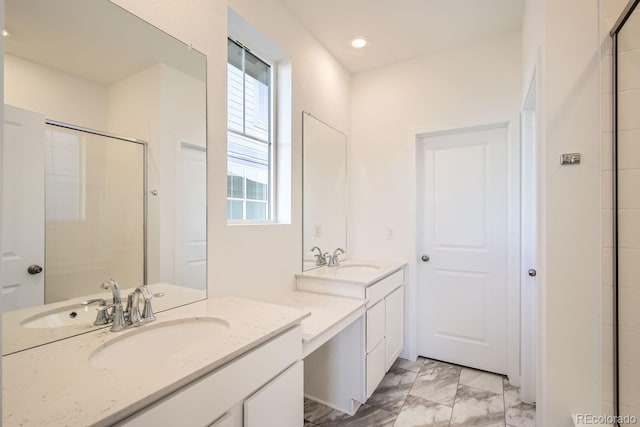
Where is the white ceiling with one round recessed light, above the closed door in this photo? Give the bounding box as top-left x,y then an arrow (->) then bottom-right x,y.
280,0 -> 525,74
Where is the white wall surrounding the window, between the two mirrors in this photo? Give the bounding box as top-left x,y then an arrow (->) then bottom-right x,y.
110,0 -> 351,298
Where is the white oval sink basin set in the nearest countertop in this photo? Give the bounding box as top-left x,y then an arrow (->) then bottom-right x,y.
89,317 -> 229,369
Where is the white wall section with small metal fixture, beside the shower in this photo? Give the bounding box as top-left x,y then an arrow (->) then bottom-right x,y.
523,0 -> 602,427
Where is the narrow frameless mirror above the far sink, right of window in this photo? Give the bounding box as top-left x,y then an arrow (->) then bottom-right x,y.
302,113 -> 347,271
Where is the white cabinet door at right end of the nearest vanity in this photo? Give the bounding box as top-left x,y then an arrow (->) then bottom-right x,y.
244,361 -> 304,427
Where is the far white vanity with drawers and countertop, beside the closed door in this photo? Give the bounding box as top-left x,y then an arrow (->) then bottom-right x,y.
296,260 -> 405,413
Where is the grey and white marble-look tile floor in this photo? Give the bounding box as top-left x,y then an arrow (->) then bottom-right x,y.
304,358 -> 536,427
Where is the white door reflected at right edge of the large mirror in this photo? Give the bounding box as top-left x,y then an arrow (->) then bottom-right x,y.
178,144 -> 207,290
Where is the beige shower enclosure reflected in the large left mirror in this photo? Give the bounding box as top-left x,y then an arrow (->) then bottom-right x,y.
44,124 -> 146,304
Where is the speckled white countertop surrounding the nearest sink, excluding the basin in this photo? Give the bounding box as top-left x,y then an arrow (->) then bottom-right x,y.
2,297 -> 309,427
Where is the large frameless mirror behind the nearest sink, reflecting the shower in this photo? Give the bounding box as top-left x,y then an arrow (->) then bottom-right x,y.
2,0 -> 206,354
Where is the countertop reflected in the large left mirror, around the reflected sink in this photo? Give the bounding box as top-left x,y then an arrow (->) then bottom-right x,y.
2,283 -> 207,355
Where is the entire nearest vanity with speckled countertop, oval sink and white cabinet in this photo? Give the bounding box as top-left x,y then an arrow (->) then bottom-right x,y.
2,297 -> 309,427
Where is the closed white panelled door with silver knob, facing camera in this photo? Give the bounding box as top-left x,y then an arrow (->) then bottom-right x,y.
418,127 -> 507,374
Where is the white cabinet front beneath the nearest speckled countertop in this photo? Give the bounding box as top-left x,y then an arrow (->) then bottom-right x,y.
117,326 -> 304,427
